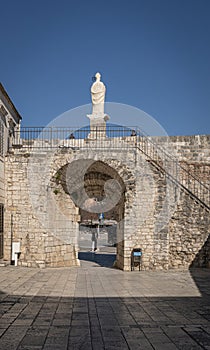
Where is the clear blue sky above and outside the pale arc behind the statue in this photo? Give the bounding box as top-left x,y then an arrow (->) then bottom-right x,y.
0,0 -> 210,135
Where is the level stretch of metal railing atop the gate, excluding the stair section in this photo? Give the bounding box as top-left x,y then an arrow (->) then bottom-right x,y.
12,125 -> 139,150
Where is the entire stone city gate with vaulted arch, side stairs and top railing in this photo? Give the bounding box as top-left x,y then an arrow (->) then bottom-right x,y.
4,127 -> 210,271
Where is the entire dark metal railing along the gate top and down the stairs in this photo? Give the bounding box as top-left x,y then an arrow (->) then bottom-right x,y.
12,125 -> 210,209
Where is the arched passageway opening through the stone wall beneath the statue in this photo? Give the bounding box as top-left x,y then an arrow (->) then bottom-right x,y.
56,159 -> 126,266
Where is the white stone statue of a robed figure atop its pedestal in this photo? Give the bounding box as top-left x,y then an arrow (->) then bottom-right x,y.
91,73 -> 106,117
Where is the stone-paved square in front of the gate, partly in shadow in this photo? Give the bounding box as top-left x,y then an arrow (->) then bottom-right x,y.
0,252 -> 210,350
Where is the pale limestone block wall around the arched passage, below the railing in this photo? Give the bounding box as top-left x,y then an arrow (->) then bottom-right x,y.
5,136 -> 210,271
